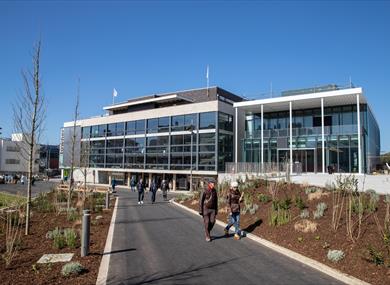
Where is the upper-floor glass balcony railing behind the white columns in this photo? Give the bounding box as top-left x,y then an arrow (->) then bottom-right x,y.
245,125 -> 358,138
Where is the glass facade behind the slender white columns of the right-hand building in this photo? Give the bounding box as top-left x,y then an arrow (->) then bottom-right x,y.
242,104 -> 380,173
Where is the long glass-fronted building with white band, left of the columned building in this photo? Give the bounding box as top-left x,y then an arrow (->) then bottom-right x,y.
60,87 -> 243,189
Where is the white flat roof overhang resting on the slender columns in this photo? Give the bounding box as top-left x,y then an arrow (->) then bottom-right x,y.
233,87 -> 367,113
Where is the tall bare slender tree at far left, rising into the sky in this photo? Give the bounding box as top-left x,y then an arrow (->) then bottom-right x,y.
13,40 -> 46,235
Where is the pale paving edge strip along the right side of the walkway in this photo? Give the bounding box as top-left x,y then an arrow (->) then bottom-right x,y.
170,200 -> 370,285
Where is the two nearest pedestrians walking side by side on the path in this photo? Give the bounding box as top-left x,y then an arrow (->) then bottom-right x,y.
199,181 -> 243,242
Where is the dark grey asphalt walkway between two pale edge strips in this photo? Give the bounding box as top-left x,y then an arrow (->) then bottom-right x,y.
103,191 -> 340,285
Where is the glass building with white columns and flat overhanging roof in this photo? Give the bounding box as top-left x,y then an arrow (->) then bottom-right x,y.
234,85 -> 380,173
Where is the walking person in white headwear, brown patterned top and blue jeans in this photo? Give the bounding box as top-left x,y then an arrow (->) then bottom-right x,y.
225,181 -> 244,240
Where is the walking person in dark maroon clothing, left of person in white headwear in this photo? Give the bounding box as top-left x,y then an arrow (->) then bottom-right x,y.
199,182 -> 218,242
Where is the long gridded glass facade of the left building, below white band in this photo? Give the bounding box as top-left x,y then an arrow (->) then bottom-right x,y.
80,112 -> 233,171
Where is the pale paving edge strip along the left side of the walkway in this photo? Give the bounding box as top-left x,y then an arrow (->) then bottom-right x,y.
96,197 -> 119,285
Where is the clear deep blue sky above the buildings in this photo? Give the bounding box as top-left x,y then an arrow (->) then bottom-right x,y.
0,1 -> 390,151
